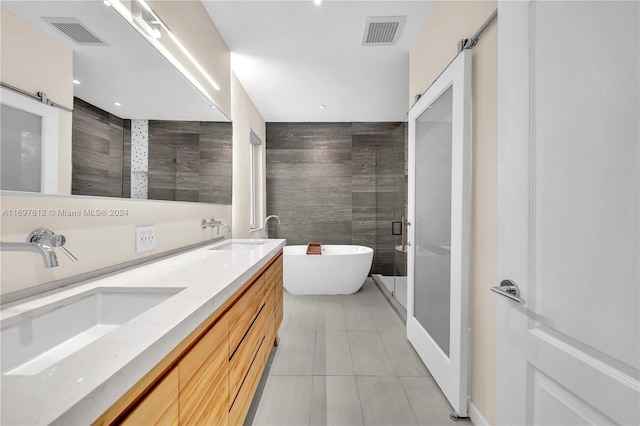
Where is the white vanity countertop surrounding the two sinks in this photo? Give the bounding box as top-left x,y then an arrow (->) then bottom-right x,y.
0,239 -> 285,425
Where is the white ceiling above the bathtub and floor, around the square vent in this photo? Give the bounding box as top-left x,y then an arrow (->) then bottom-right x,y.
203,0 -> 433,122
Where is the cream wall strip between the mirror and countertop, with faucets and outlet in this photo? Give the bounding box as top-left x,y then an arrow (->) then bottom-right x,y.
0,193 -> 231,294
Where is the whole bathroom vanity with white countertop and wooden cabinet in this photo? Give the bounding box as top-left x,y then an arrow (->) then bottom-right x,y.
0,240 -> 284,425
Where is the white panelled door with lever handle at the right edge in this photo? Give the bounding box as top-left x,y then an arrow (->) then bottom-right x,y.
496,1 -> 640,425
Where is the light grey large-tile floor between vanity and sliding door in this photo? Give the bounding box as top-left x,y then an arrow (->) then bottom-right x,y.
248,278 -> 470,426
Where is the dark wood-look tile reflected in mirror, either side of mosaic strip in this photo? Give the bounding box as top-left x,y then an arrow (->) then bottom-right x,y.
72,98 -> 233,204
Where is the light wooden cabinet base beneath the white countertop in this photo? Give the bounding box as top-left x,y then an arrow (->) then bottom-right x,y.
102,253 -> 283,426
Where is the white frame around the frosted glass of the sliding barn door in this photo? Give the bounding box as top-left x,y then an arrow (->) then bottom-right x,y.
406,50 -> 471,417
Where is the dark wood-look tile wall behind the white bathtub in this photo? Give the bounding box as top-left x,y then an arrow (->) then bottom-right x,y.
266,123 -> 406,275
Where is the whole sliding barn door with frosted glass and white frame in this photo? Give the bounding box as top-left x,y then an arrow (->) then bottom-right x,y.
407,51 -> 471,416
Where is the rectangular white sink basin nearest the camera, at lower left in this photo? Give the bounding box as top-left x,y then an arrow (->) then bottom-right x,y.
0,287 -> 183,375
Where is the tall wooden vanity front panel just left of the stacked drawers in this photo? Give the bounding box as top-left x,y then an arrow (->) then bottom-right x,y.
178,315 -> 229,425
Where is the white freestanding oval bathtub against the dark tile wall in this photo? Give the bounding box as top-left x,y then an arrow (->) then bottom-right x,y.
283,245 -> 373,294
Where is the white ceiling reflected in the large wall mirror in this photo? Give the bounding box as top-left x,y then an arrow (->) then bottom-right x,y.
2,0 -> 229,121
